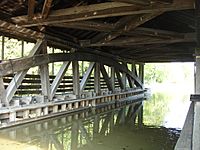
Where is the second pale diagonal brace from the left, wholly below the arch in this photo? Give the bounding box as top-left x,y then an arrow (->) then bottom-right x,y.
50,61 -> 70,100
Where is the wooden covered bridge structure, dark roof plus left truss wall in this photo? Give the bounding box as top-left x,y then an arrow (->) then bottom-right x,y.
0,0 -> 200,150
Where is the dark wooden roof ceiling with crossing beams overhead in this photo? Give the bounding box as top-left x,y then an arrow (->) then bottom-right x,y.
0,0 -> 196,62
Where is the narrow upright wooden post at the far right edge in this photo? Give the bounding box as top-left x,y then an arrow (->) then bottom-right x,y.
192,0 -> 200,150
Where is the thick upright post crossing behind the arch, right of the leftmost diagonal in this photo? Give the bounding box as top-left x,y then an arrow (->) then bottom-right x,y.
39,41 -> 50,99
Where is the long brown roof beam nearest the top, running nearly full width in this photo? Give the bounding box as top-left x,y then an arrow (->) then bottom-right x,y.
12,0 -> 194,27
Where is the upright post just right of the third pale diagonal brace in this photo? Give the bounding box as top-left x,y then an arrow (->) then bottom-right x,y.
94,63 -> 101,95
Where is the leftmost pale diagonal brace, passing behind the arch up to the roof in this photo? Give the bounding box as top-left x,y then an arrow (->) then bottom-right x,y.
6,40 -> 43,103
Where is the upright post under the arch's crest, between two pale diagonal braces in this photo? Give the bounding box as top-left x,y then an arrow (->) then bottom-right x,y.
72,61 -> 80,98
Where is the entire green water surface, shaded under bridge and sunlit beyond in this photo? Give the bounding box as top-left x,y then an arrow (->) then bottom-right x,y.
0,89 -> 188,150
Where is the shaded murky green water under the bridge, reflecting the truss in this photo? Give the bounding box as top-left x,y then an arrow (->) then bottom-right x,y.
0,97 -> 178,150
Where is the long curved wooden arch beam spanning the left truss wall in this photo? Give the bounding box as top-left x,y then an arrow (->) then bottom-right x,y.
0,52 -> 142,86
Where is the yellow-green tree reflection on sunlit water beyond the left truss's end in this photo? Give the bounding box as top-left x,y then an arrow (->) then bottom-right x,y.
144,93 -> 171,126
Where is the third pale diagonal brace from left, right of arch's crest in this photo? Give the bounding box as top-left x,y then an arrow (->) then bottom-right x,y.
80,62 -> 95,92
